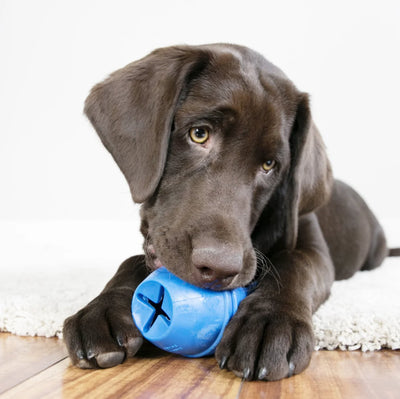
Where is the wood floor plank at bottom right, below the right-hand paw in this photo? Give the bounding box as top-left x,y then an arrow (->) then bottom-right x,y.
239,351 -> 400,399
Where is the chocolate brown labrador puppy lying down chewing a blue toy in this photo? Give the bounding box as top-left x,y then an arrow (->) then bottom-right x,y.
64,44 -> 396,380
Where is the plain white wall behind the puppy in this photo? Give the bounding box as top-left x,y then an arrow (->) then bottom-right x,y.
0,0 -> 400,268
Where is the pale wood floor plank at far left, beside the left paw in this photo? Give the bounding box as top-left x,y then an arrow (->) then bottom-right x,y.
0,333 -> 67,394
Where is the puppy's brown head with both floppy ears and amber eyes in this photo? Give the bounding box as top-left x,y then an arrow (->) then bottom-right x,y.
85,44 -> 331,289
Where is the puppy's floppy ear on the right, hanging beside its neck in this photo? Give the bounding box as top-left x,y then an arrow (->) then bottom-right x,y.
285,93 -> 333,248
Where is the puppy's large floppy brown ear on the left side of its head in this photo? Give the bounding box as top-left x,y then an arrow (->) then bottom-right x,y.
85,46 -> 207,202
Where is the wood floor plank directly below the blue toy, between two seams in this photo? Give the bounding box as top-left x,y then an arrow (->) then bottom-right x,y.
2,355 -> 241,399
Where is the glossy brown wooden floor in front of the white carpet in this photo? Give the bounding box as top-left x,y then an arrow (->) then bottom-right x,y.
0,333 -> 400,399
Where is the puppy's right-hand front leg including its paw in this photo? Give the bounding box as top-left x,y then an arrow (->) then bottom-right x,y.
216,214 -> 334,380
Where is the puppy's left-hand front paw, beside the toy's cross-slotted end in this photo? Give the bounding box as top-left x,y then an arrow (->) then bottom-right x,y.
63,291 -> 143,368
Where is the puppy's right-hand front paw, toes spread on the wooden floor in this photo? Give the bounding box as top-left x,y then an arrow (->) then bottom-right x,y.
215,297 -> 314,381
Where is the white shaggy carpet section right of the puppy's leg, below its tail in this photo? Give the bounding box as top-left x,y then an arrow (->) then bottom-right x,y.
313,258 -> 400,351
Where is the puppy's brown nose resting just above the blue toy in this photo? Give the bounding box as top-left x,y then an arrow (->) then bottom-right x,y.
192,245 -> 243,288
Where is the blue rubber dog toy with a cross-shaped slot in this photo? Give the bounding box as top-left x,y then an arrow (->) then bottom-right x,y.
132,267 -> 248,357
